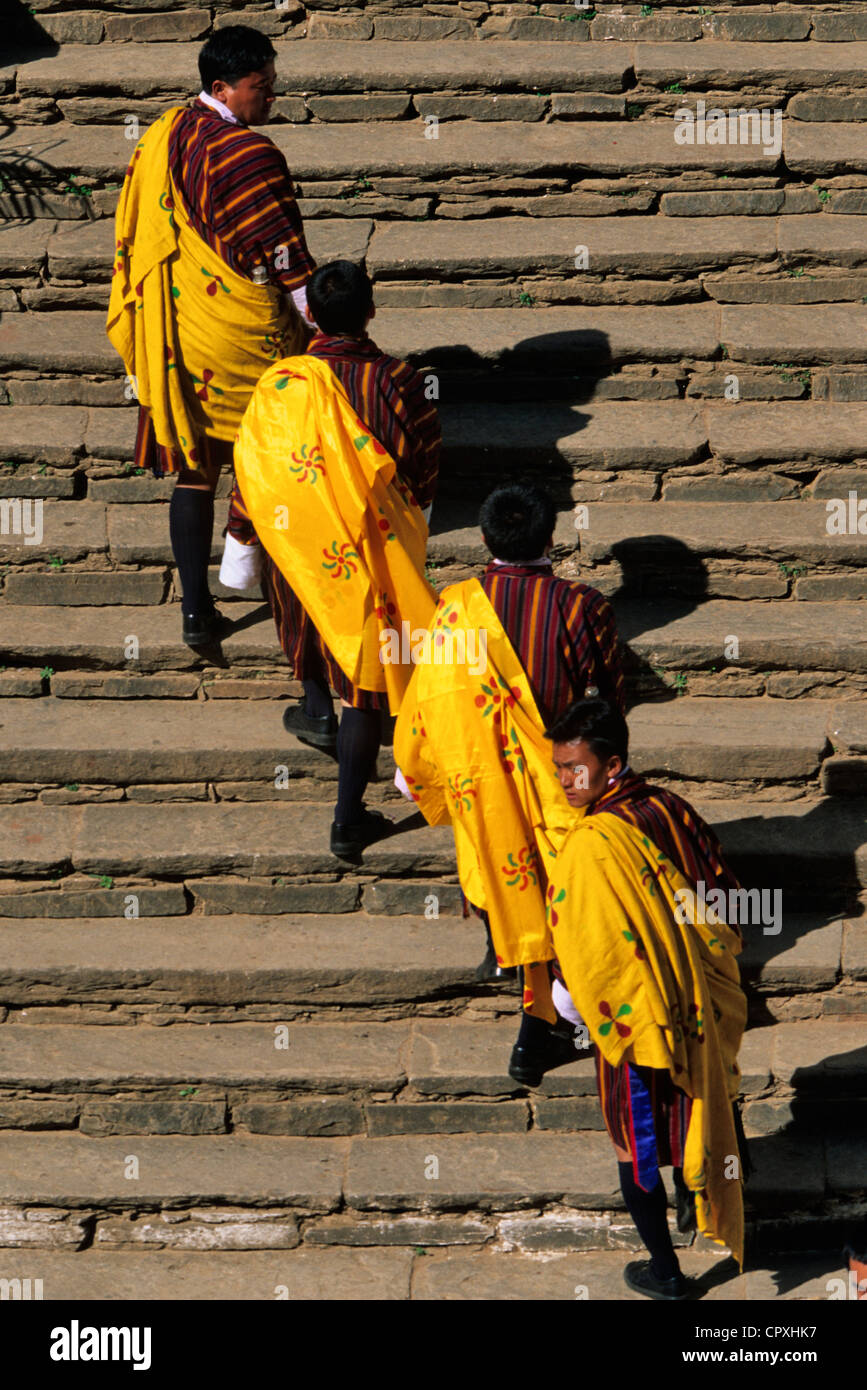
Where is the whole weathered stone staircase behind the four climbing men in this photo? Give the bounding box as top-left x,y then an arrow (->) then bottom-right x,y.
0,0 -> 867,1298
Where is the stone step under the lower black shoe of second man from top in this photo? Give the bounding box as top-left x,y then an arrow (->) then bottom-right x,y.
0,798 -> 867,910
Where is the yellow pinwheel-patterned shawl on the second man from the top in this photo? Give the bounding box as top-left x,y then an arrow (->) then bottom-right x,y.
235,356 -> 436,713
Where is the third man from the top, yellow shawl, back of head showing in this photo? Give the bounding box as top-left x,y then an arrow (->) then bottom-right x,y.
395,484 -> 624,1086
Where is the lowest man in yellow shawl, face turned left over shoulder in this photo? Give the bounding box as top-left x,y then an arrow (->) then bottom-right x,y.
547,699 -> 746,1298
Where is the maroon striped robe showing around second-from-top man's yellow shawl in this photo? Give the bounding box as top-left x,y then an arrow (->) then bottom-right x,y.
226,334 -> 440,709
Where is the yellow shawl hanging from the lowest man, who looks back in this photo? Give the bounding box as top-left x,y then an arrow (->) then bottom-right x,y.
549,812 -> 746,1264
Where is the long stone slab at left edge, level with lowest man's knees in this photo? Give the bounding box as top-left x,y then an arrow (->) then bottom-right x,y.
0,1134 -> 345,1211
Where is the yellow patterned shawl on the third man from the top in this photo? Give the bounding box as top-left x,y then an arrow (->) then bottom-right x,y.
395,580 -> 575,978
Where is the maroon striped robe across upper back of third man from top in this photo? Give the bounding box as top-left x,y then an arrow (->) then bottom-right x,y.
482,563 -> 625,724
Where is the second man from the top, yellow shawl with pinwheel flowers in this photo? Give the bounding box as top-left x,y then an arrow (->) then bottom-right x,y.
221,261 -> 440,860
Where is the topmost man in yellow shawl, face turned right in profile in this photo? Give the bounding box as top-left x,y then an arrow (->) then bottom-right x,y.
107,25 -> 314,646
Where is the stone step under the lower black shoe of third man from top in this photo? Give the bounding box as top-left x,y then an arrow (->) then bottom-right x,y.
0,1011 -> 867,1138
